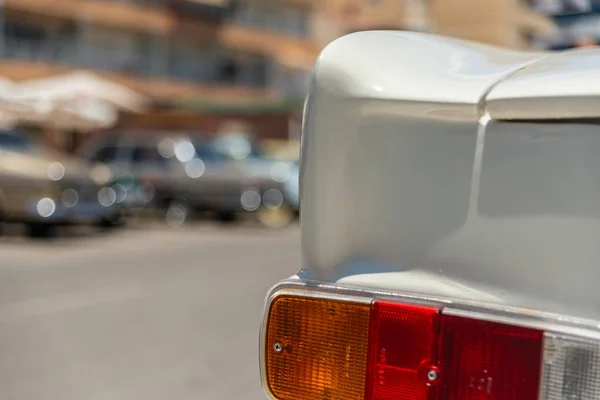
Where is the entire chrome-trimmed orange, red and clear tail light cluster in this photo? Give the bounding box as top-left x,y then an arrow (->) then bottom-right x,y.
261,283 -> 600,400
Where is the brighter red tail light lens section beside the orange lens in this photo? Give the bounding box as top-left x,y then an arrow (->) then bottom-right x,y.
365,302 -> 440,400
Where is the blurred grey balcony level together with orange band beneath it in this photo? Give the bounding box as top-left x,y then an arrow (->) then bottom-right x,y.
0,10 -> 286,100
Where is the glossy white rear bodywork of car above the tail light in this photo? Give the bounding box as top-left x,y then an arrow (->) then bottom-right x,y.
300,32 -> 600,320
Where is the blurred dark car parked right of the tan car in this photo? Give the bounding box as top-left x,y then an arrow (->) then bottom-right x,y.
85,135 -> 294,227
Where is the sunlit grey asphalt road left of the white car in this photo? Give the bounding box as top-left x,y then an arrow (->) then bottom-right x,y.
0,225 -> 300,400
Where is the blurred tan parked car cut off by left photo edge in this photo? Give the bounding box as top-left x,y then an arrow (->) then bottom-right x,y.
0,129 -> 120,237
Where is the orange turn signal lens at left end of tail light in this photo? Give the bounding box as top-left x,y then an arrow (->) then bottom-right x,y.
265,295 -> 371,400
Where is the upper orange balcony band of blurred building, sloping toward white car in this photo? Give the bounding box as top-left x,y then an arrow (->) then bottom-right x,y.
4,0 -> 318,68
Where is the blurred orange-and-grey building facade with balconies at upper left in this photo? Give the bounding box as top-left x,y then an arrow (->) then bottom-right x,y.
0,0 -> 314,99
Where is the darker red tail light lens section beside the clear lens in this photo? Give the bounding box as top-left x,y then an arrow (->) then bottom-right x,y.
440,315 -> 543,400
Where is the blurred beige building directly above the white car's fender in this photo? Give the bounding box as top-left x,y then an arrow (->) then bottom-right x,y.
314,0 -> 554,48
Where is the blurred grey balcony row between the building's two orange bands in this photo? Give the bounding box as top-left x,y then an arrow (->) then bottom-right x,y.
0,30 -> 282,89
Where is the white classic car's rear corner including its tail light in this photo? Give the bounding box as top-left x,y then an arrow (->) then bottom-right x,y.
260,32 -> 600,400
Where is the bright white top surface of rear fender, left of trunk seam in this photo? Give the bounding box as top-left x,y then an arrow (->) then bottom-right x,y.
315,32 -> 543,109
